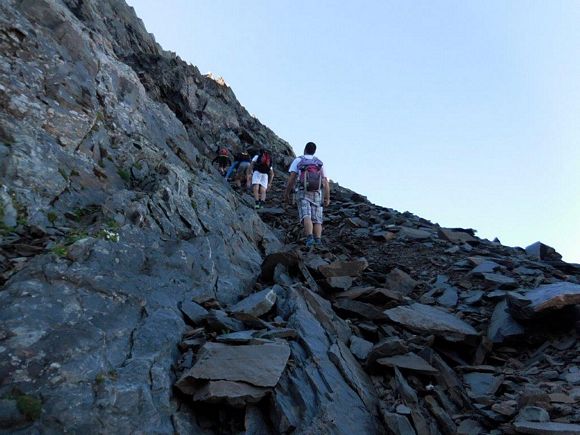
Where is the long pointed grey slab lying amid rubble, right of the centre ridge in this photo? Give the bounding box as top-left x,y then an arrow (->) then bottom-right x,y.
385,303 -> 479,341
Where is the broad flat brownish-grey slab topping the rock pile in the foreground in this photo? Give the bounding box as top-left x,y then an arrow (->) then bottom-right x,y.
180,342 -> 290,387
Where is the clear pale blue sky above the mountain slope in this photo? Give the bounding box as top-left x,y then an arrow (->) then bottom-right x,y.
129,0 -> 580,262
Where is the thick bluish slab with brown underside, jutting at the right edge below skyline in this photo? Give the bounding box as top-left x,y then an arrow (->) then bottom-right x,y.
507,282 -> 580,320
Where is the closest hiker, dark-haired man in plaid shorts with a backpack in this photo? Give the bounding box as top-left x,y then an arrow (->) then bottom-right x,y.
284,142 -> 330,247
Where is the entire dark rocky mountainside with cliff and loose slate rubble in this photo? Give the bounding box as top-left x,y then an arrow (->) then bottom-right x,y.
0,0 -> 580,434
